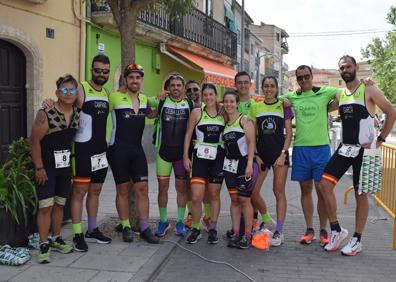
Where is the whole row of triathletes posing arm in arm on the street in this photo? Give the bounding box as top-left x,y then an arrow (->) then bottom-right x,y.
30,55 -> 396,263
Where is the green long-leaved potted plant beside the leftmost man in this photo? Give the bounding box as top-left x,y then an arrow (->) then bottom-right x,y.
0,138 -> 37,225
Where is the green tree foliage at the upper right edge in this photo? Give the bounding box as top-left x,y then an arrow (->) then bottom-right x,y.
362,6 -> 396,103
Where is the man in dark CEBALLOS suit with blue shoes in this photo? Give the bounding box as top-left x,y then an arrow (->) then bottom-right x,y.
155,75 -> 194,237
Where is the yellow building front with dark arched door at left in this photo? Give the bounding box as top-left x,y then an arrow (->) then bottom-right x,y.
0,0 -> 85,163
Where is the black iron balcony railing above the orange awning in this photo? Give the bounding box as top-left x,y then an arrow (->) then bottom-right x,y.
91,4 -> 237,60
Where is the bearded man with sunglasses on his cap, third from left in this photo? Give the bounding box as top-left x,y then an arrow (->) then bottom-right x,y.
107,64 -> 159,244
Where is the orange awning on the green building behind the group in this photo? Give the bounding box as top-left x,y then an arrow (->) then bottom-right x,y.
168,46 -> 237,88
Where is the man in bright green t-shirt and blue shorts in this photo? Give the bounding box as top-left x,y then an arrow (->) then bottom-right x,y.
283,65 -> 339,247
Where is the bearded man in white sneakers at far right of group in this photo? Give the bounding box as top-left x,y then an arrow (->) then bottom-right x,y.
321,55 -> 396,256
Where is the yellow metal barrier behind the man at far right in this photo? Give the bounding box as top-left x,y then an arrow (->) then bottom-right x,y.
344,144 -> 396,250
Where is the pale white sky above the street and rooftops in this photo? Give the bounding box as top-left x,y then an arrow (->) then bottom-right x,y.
238,0 -> 396,70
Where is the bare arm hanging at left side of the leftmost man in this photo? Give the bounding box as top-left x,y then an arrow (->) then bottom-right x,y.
29,111 -> 48,184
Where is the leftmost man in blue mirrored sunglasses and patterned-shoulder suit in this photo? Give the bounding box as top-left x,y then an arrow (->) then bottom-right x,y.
30,75 -> 80,263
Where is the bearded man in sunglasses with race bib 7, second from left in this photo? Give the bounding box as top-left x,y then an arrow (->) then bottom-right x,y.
71,55 -> 111,252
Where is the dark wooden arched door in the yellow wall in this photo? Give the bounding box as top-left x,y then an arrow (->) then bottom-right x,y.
0,39 -> 26,164
